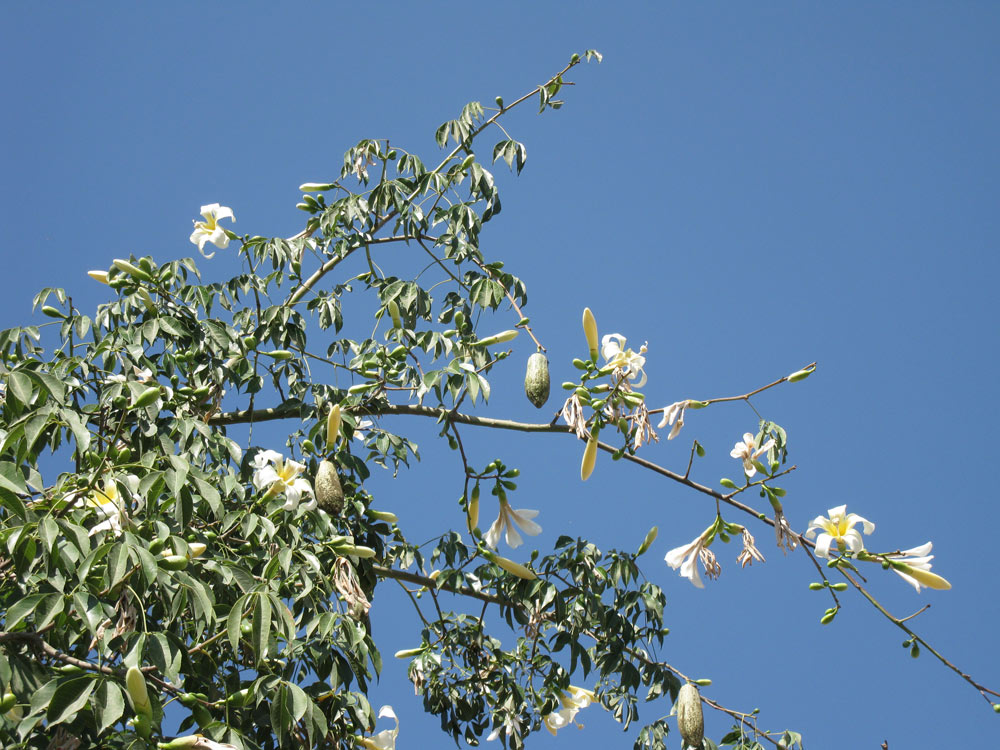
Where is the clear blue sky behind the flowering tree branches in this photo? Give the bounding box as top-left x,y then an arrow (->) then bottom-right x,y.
0,2 -> 1000,750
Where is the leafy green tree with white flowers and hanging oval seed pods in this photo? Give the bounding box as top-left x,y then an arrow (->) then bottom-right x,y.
0,51 -> 997,748
